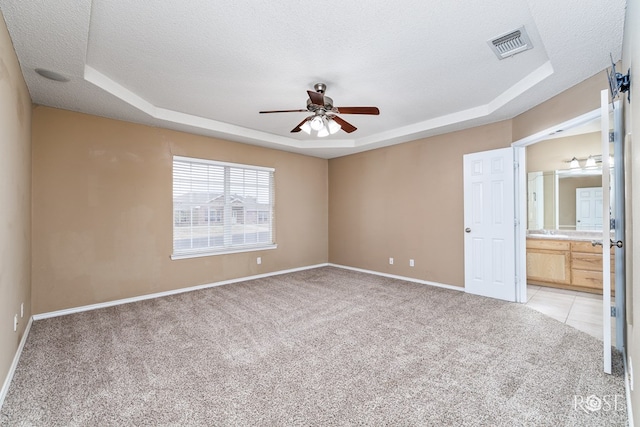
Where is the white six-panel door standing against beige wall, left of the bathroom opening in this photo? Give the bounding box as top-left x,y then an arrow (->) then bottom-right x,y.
463,147 -> 516,301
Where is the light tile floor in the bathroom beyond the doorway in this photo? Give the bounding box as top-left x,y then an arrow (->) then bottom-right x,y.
526,285 -> 616,342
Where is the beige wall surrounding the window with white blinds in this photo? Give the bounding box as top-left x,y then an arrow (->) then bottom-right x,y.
32,107 -> 328,313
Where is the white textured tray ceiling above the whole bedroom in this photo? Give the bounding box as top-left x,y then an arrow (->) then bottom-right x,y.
0,0 -> 626,158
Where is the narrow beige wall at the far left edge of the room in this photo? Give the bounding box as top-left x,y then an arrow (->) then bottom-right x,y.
0,12 -> 31,402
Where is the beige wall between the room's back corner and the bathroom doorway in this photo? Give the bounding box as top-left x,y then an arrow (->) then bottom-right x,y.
329,121 -> 511,286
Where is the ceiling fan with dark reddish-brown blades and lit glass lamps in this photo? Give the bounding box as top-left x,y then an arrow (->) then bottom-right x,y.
260,83 -> 380,137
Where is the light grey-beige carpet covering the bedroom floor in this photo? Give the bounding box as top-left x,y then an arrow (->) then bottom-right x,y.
0,267 -> 627,426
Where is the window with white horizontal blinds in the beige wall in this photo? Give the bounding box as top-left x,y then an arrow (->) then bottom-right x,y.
172,156 -> 276,259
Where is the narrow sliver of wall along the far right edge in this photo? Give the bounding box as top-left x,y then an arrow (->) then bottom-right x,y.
619,0 -> 640,425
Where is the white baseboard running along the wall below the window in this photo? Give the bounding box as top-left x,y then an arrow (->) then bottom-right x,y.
33,263 -> 329,320
